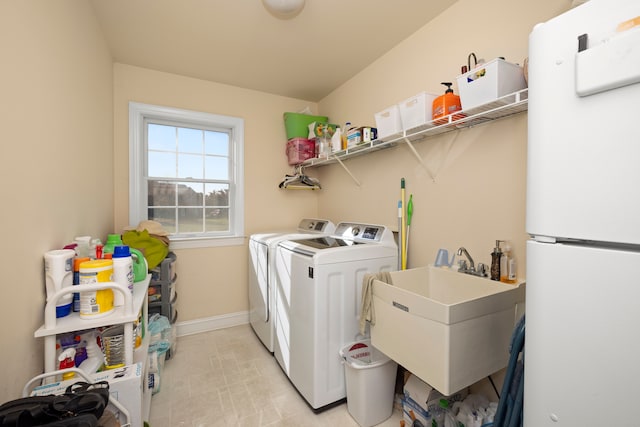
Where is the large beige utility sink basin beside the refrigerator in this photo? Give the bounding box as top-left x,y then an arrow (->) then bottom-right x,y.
371,265 -> 525,395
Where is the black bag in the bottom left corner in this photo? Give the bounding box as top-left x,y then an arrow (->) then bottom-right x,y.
0,381 -> 109,427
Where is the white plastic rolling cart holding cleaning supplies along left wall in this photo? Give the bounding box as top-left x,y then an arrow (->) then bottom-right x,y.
34,274 -> 151,427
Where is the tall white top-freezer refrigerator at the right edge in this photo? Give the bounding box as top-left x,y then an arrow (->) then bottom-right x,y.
524,0 -> 640,427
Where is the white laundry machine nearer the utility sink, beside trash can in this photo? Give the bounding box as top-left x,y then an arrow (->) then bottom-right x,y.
274,223 -> 398,409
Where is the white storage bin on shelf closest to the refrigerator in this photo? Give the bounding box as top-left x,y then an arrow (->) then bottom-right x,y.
457,58 -> 527,110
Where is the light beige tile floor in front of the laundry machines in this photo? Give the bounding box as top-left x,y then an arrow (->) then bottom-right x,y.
150,325 -> 401,427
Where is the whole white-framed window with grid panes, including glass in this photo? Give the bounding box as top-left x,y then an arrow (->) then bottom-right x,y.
129,102 -> 244,248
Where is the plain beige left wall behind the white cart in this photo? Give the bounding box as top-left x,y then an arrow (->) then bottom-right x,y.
0,0 -> 113,402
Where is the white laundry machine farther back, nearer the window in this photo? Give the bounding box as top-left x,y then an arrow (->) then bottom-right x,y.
249,218 -> 336,353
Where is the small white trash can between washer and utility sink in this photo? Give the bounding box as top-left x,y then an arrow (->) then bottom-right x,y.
340,339 -> 398,427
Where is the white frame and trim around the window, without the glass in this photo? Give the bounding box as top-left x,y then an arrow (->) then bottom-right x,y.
129,102 -> 245,249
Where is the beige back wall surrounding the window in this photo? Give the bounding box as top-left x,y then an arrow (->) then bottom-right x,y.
114,64 -> 318,321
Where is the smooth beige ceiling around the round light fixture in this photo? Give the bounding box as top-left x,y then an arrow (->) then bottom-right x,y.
91,0 -> 457,102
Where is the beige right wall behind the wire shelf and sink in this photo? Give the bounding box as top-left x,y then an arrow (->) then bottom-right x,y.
317,0 -> 570,278
